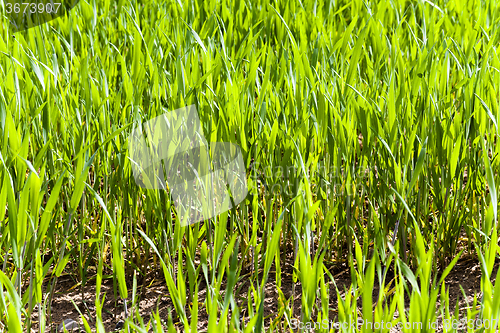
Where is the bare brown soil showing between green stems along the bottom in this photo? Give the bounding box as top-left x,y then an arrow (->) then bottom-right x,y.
28,252 -> 500,332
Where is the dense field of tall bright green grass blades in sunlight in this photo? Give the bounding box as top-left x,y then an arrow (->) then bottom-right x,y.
0,0 -> 500,332
